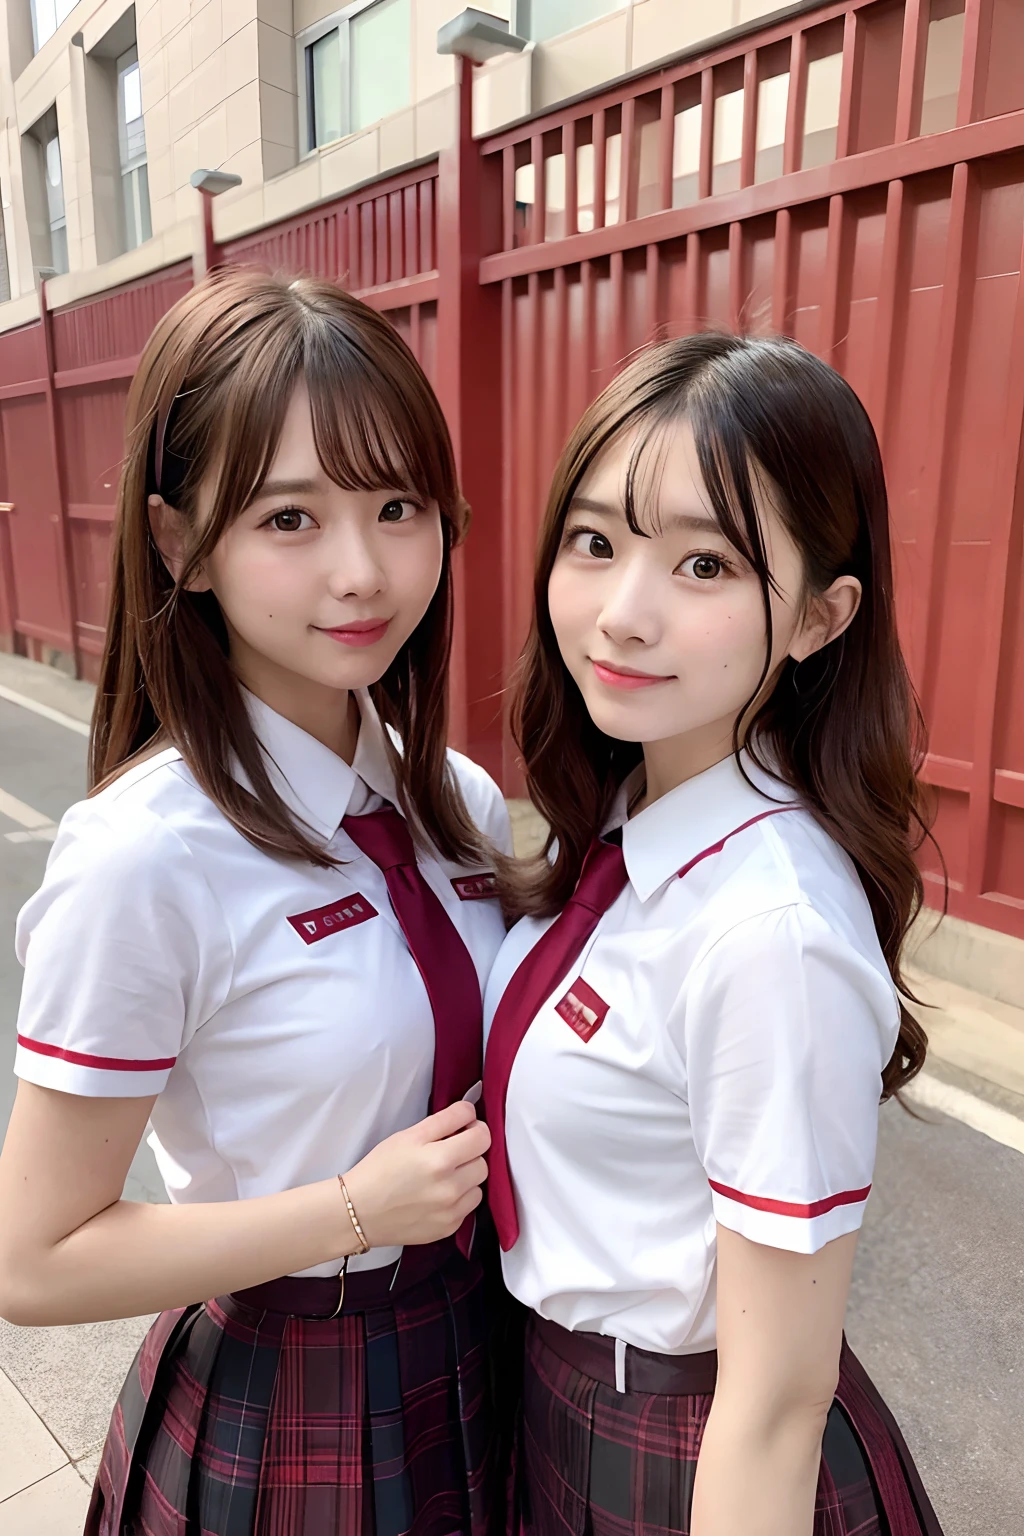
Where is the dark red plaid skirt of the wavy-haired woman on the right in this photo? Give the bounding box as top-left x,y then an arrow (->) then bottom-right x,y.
521,1316 -> 943,1536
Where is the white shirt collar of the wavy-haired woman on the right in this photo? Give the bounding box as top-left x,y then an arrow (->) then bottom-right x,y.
605,751 -> 798,902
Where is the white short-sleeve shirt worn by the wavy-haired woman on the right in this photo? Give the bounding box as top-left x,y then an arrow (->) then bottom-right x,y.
485,757 -> 900,1353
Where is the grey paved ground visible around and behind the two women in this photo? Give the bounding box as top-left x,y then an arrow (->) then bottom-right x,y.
0,657 -> 1024,1536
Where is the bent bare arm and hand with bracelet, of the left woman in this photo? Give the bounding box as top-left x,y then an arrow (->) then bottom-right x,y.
0,1081 -> 490,1326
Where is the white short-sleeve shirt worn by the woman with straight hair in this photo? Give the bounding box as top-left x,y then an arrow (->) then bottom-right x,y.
15,696 -> 511,1275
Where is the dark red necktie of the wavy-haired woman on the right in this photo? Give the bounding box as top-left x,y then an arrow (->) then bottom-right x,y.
484,839 -> 626,1250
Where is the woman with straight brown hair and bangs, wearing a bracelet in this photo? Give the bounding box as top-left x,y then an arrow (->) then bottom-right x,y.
0,270 -> 508,1536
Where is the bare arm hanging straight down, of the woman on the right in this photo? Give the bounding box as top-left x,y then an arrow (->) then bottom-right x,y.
691,1226 -> 857,1536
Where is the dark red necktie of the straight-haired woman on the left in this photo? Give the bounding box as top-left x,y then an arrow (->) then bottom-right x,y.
341,805 -> 484,1114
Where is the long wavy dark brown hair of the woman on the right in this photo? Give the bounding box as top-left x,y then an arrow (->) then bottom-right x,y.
505,335 -> 927,1097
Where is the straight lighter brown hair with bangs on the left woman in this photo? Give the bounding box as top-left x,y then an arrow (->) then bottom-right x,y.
89,267 -> 481,865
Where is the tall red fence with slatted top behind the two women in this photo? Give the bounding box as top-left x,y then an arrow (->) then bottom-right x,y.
0,0 -> 1024,935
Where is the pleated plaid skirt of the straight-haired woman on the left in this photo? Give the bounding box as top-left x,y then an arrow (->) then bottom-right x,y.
86,1244 -> 504,1536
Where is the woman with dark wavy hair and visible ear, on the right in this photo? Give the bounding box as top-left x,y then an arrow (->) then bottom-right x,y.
484,335 -> 940,1536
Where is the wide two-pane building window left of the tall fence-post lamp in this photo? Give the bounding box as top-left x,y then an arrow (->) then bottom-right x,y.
298,0 -> 411,151
